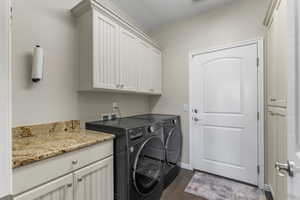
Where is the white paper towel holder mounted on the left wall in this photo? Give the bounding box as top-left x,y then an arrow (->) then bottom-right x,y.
31,45 -> 44,83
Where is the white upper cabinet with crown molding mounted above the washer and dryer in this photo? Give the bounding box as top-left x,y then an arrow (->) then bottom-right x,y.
72,0 -> 162,95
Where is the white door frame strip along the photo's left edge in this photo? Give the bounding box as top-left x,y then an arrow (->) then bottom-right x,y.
0,0 -> 12,199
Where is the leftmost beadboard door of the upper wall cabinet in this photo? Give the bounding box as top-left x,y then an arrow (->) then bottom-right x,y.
93,12 -> 119,89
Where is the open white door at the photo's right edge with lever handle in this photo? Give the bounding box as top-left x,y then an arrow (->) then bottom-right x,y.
280,0 -> 300,200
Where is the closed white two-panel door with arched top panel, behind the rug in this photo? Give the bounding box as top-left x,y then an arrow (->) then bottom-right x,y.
190,43 -> 258,185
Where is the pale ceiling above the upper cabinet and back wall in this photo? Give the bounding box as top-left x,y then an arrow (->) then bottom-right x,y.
111,0 -> 233,31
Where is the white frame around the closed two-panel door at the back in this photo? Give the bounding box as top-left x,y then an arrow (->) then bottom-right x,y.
189,38 -> 265,189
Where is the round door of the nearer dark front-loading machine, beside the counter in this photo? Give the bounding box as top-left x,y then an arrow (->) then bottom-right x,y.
133,137 -> 165,195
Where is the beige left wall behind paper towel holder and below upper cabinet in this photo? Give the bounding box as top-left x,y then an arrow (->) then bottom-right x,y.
12,0 -> 149,126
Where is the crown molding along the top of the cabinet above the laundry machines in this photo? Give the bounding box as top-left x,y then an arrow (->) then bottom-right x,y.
71,0 -> 161,50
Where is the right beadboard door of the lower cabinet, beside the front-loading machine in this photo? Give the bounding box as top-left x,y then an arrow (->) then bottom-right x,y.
74,157 -> 113,200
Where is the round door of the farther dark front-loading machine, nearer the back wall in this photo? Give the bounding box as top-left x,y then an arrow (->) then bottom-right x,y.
165,127 -> 181,165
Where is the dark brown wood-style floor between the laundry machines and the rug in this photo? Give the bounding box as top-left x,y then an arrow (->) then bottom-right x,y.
161,169 -> 265,200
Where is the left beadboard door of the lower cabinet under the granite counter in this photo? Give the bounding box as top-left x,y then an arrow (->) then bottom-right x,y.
14,175 -> 73,200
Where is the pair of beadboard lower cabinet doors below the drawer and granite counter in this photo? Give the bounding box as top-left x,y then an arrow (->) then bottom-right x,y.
14,156 -> 113,200
